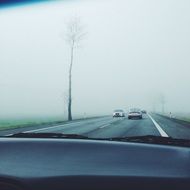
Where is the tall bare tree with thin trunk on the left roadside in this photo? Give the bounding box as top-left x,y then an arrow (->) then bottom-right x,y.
66,17 -> 85,121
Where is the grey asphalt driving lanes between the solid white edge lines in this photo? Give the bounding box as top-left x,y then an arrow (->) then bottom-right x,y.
24,115 -> 160,138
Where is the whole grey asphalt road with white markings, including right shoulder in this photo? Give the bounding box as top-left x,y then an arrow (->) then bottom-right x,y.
0,114 -> 190,139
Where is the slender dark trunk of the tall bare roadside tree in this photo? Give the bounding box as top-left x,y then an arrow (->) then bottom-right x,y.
68,44 -> 74,121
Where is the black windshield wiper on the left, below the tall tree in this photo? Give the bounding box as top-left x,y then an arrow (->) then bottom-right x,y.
6,133 -> 88,139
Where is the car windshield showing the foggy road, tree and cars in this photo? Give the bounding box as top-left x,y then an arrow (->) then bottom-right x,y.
0,0 -> 190,144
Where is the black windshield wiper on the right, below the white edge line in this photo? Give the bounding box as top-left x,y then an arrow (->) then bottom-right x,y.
110,135 -> 190,147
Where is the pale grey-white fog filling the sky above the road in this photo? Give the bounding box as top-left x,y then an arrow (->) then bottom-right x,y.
0,0 -> 190,118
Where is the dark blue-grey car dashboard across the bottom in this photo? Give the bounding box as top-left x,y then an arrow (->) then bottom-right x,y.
0,138 -> 190,190
